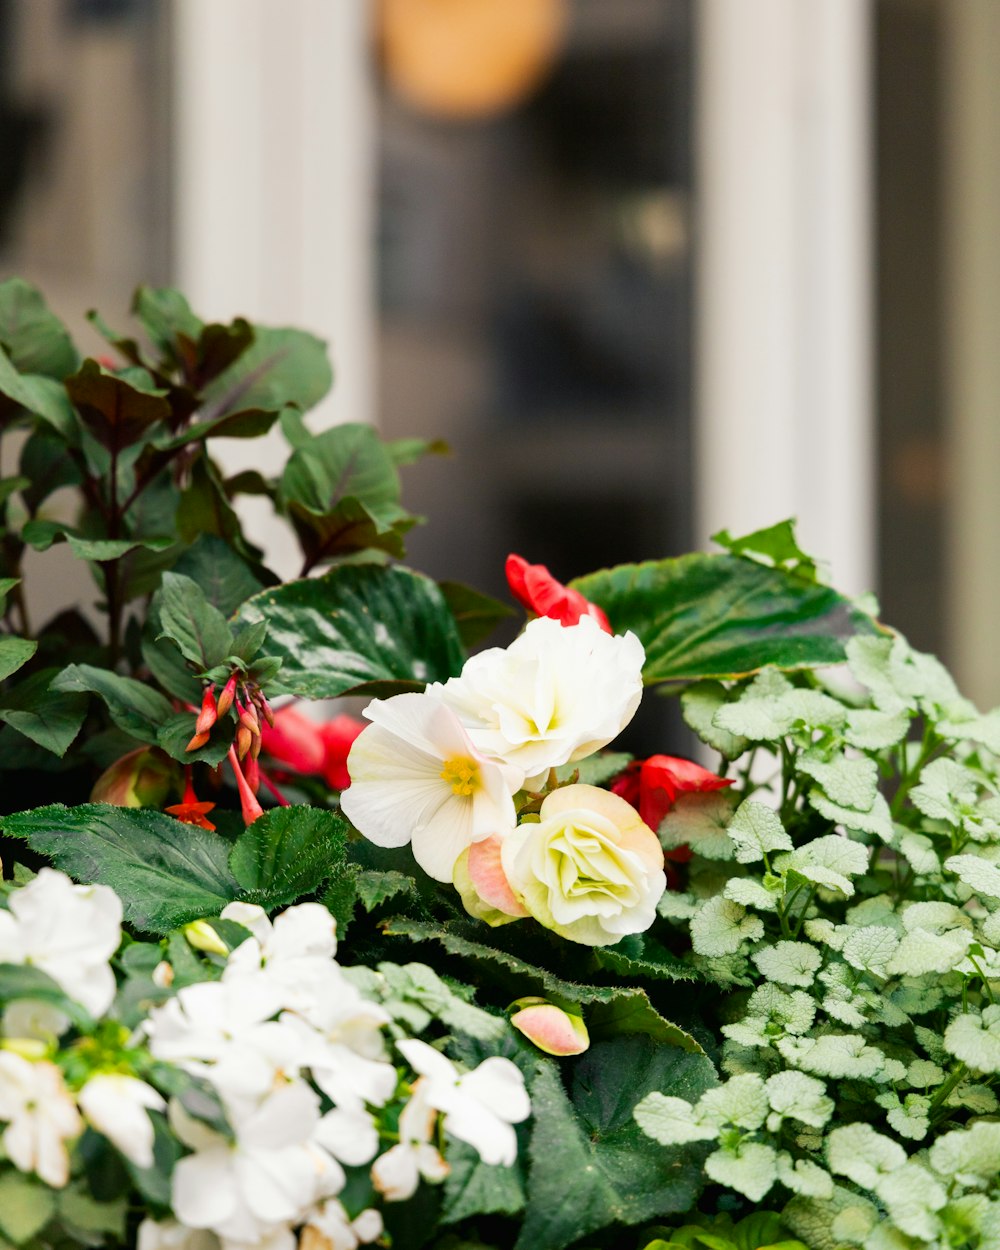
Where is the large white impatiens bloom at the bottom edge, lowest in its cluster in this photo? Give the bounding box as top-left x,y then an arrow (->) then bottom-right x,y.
170,1081 -> 345,1245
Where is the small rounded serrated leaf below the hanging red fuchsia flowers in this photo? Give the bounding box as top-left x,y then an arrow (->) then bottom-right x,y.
229,808 -> 348,908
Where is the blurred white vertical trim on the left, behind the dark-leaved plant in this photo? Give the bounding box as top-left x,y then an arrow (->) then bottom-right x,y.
173,0 -> 375,574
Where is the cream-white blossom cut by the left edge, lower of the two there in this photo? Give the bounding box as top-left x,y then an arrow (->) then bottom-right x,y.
0,1050 -> 84,1189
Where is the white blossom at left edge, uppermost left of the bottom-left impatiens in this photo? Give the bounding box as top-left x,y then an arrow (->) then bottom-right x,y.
0,868 -> 121,1016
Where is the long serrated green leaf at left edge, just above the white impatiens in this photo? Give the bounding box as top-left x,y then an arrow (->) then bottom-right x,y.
3,803 -> 239,934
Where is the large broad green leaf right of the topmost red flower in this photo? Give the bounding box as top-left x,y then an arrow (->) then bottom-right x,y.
571,553 -> 878,683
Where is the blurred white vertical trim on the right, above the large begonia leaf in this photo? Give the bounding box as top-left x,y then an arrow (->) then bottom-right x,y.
694,0 -> 875,591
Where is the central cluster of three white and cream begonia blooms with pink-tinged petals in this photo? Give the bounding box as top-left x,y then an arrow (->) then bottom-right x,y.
341,616 -> 666,945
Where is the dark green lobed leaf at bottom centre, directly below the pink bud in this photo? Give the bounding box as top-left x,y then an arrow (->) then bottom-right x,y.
518,1038 -> 718,1250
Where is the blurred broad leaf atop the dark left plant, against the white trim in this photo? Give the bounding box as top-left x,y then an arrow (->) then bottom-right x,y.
203,325 -> 333,420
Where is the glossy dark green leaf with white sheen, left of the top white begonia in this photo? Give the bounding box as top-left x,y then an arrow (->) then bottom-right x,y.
240,565 -> 464,699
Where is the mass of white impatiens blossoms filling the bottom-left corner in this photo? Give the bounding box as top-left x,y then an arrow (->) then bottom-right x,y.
0,870 -> 530,1250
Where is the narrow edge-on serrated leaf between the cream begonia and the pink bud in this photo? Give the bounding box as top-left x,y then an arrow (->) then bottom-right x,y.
383,918 -> 704,1055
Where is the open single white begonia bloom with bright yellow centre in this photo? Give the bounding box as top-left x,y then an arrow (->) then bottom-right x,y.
340,694 -> 524,883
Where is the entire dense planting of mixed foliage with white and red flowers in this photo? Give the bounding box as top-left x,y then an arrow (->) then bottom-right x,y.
0,281 -> 1000,1250
